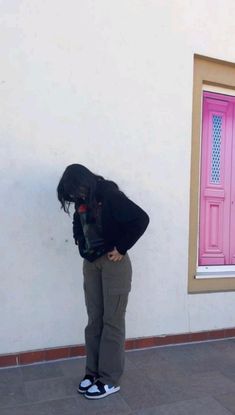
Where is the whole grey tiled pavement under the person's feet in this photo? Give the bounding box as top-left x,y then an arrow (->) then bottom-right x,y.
0,339 -> 235,415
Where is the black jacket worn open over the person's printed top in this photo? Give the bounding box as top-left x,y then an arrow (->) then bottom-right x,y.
73,180 -> 149,262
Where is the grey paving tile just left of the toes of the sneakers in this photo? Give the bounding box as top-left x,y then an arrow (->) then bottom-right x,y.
25,377 -> 78,402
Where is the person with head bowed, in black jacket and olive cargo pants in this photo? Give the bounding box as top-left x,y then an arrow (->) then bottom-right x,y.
57,164 -> 149,399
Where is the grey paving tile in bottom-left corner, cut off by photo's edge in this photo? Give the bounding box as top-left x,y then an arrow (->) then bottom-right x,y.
1,398 -> 81,415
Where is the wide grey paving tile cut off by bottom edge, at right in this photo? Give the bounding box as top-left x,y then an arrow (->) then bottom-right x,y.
133,398 -> 231,415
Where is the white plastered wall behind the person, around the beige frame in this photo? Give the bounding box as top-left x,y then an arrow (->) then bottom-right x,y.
0,0 -> 235,353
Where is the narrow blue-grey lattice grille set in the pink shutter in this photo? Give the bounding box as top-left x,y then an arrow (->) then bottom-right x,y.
211,115 -> 222,183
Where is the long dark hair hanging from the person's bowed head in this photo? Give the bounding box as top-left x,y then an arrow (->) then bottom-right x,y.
57,164 -> 119,214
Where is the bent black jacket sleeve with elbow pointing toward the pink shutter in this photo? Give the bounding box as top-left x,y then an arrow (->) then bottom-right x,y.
110,192 -> 149,255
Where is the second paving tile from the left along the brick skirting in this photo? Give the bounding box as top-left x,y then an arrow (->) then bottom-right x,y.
21,362 -> 63,381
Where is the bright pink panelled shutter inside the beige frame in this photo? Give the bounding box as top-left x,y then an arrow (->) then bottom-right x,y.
199,92 -> 235,265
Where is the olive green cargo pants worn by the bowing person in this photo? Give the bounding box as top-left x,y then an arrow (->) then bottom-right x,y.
83,254 -> 132,385
